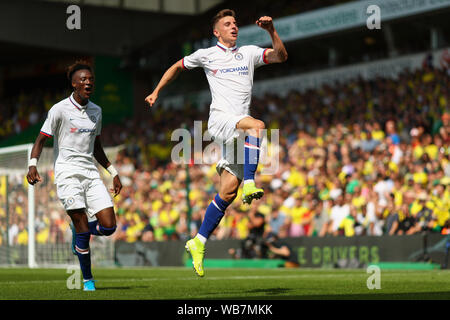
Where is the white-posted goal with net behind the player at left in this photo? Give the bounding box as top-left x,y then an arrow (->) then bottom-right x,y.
0,144 -> 120,268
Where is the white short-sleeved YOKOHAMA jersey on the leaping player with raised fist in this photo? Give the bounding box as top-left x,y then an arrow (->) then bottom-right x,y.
182,42 -> 267,116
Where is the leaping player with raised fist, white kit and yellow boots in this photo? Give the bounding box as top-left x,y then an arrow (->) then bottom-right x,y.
145,9 -> 287,277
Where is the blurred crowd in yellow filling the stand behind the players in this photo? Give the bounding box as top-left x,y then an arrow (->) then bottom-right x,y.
0,63 -> 450,244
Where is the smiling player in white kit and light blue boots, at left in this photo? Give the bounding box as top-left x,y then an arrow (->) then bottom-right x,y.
27,61 -> 122,291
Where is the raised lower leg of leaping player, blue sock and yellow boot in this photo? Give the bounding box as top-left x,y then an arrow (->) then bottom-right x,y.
236,116 -> 265,204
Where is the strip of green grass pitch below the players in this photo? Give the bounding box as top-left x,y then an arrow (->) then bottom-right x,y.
0,267 -> 450,300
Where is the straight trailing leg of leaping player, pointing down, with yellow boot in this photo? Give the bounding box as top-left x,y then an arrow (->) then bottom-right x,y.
185,170 -> 241,277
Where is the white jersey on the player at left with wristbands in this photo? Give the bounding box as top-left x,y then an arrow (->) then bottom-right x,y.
41,94 -> 102,183
